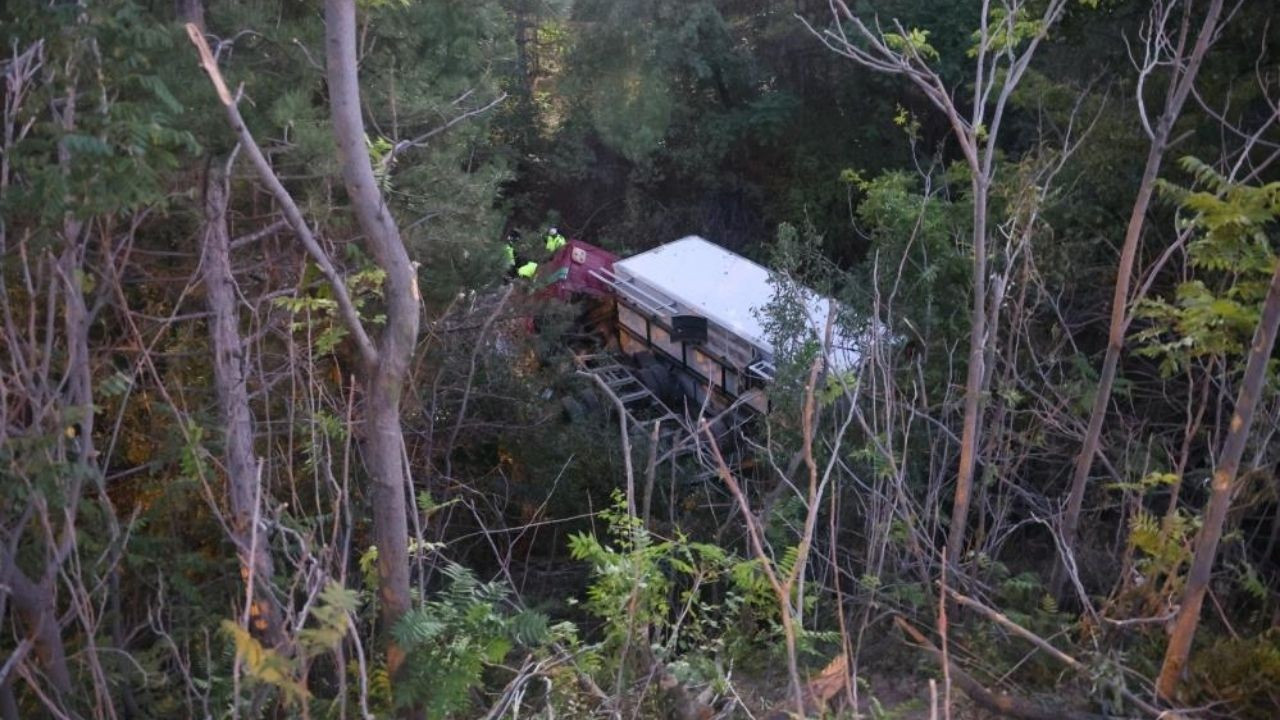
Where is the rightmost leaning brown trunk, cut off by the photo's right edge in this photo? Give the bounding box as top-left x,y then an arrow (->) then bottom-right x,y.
1156,252 -> 1280,698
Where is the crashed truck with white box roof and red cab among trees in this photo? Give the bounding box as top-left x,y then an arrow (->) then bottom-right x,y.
541,236 -> 856,443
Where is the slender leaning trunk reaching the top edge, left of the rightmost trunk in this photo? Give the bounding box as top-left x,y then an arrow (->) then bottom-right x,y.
1052,0 -> 1222,594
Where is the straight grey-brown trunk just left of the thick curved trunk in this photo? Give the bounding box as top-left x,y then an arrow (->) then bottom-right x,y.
201,163 -> 284,646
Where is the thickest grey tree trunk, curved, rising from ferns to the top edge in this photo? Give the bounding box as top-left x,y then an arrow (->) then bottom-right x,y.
325,0 -> 420,676
